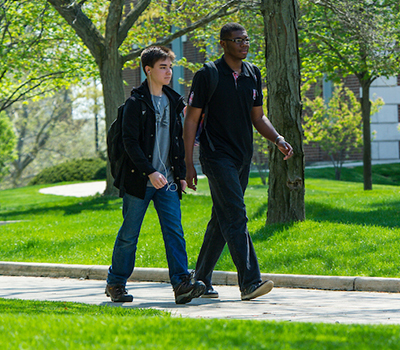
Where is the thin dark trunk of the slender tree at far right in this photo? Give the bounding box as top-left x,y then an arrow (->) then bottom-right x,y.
360,80 -> 372,190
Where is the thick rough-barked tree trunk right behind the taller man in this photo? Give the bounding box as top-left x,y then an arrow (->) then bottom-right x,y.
261,0 -> 305,223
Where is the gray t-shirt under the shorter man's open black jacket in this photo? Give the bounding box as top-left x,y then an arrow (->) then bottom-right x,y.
148,94 -> 174,186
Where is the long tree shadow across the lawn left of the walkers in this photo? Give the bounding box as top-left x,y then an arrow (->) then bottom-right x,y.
0,196 -> 122,220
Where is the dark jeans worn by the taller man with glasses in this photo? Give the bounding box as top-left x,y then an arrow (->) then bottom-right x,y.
196,156 -> 261,291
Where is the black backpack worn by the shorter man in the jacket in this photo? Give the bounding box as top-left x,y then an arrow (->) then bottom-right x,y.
107,94 -> 146,179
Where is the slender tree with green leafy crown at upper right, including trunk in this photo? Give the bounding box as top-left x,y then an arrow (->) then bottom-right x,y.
299,0 -> 400,190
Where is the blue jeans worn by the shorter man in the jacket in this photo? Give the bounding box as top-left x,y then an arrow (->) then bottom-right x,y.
107,187 -> 189,287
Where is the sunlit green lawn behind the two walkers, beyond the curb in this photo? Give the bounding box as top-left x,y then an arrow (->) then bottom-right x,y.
0,164 -> 400,277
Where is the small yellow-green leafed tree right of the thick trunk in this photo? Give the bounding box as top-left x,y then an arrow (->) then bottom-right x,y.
303,84 -> 383,180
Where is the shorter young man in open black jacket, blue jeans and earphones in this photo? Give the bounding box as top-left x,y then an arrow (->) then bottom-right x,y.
106,47 -> 205,304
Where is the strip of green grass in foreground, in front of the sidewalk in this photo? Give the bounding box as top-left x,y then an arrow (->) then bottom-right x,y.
0,299 -> 400,350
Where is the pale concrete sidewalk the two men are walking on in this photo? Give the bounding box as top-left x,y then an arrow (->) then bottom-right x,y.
0,276 -> 400,324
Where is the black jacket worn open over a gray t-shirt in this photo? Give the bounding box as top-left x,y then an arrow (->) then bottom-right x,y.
114,80 -> 186,199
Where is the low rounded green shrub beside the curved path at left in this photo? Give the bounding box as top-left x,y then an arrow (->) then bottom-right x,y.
29,158 -> 106,185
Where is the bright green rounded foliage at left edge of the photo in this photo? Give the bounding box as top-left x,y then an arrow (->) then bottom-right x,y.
0,112 -> 16,180
